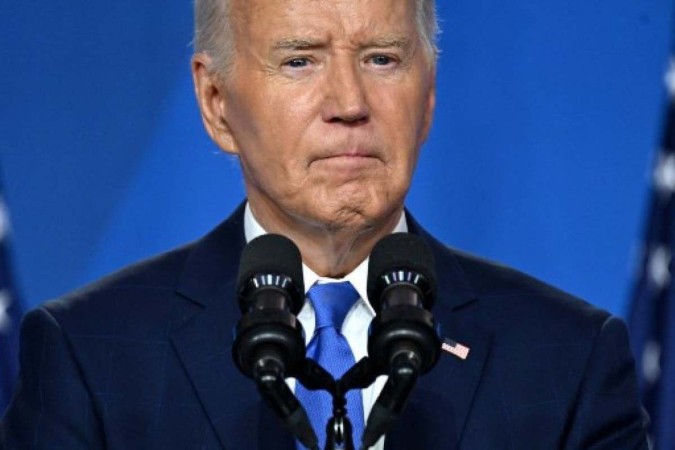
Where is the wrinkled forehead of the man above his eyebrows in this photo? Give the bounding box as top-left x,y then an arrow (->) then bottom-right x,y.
230,0 -> 418,44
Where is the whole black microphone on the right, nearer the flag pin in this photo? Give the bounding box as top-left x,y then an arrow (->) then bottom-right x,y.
361,233 -> 441,449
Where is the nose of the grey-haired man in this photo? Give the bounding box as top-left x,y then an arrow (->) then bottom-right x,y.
322,60 -> 370,124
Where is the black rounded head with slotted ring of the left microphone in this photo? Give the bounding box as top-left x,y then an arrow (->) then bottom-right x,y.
237,234 -> 305,314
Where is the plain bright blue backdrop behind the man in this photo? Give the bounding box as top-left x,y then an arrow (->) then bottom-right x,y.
0,0 -> 673,314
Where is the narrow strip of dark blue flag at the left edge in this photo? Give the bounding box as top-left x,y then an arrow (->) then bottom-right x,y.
0,177 -> 22,416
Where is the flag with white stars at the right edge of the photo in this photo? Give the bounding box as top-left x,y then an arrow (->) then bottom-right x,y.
629,51 -> 675,450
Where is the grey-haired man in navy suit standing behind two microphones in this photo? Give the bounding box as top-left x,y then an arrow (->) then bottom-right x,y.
0,0 -> 647,450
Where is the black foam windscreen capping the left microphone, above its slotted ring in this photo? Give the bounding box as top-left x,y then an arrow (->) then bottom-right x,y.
237,234 -> 305,295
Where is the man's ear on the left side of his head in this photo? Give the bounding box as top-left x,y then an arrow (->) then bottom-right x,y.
192,53 -> 238,155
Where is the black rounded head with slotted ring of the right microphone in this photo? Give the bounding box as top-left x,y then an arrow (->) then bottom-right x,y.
368,233 -> 436,312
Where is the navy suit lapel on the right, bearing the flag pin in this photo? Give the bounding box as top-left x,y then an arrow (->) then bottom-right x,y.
385,214 -> 491,450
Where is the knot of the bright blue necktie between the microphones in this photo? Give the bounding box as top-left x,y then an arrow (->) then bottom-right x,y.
307,281 -> 360,331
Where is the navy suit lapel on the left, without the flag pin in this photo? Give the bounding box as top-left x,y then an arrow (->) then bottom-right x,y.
171,205 -> 293,450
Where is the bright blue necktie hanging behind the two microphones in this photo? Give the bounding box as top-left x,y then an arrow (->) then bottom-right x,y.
295,282 -> 364,450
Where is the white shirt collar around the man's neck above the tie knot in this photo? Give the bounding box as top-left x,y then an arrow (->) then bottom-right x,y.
244,202 -> 408,314
